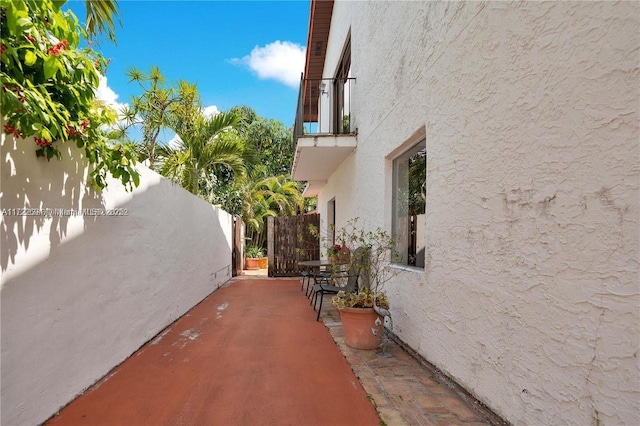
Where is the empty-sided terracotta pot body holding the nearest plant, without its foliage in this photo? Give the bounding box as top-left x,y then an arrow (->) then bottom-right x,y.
340,308 -> 383,349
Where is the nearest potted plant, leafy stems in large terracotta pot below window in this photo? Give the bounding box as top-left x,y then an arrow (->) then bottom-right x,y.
331,218 -> 398,349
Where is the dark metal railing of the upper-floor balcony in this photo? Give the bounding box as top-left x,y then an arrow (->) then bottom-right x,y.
294,78 -> 356,143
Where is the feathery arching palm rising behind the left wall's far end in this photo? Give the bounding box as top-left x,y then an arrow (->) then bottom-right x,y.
160,110 -> 247,195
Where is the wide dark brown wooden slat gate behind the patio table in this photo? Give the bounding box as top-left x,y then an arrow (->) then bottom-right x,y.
267,213 -> 320,277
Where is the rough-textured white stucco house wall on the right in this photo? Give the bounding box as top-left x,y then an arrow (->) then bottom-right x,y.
318,1 -> 640,425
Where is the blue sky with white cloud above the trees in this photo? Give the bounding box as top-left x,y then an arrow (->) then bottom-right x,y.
68,0 -> 310,133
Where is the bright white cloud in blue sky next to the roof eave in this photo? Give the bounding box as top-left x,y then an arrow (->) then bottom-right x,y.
231,40 -> 306,88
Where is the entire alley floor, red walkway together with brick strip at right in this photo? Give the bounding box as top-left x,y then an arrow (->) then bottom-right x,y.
46,270 -> 508,426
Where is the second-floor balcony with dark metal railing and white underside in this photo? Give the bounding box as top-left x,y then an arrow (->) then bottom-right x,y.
291,78 -> 357,196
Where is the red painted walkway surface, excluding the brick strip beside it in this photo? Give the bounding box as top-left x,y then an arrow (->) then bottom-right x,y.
46,277 -> 379,425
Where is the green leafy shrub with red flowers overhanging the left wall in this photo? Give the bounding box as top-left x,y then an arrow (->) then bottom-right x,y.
0,0 -> 139,189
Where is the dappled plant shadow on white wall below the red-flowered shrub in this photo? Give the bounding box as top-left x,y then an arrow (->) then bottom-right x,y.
0,135 -> 104,272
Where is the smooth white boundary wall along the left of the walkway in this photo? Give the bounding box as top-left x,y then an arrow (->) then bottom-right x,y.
0,135 -> 232,426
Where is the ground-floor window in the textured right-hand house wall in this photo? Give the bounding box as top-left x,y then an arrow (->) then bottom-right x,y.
393,139 -> 427,268
